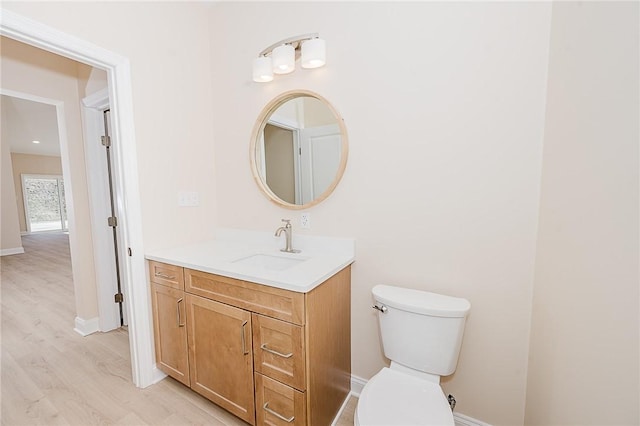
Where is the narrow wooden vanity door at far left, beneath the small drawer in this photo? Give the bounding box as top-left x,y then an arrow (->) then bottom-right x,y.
151,283 -> 189,386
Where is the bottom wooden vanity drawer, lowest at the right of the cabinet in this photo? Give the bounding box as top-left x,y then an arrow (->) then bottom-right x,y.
255,373 -> 307,426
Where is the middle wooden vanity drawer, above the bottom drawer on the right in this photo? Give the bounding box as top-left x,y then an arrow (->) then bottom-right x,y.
252,314 -> 306,391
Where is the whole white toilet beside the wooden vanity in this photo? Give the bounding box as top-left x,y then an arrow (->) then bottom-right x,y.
354,285 -> 471,426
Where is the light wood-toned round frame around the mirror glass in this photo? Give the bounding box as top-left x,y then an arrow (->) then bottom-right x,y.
249,90 -> 349,210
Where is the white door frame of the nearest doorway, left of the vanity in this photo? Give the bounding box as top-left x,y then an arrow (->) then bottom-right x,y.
0,9 -> 160,387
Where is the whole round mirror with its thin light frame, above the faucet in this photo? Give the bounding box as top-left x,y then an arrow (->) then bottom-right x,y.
249,90 -> 348,209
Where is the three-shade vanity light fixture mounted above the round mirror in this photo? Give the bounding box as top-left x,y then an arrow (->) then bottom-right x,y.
253,33 -> 327,83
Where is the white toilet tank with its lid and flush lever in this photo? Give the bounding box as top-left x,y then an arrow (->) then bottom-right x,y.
372,285 -> 471,376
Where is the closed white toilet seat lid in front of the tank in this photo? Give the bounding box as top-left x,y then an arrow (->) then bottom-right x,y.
355,367 -> 454,426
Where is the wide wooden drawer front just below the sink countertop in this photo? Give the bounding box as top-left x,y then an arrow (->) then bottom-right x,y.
184,269 -> 304,324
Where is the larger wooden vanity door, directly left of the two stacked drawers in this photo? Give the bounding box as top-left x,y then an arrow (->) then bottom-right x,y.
186,294 -> 255,424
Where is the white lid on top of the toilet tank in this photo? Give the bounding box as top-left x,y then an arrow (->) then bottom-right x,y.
372,285 -> 471,318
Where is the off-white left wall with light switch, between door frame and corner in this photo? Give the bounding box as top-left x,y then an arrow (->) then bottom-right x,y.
2,1 -> 216,248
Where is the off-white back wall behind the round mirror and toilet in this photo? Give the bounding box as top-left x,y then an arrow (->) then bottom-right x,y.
211,3 -> 551,424
